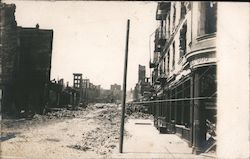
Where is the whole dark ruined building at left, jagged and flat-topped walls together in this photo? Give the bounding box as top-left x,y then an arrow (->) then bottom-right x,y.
0,3 -> 53,115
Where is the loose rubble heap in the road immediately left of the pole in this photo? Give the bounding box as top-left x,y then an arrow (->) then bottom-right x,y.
69,104 -> 126,155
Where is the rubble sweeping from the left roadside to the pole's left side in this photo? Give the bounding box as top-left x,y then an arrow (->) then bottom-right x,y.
2,103 -> 129,157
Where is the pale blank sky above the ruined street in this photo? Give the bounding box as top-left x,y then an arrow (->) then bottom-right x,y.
4,0 -> 157,89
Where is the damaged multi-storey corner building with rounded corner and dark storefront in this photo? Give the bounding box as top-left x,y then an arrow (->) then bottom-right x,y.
147,1 -> 217,152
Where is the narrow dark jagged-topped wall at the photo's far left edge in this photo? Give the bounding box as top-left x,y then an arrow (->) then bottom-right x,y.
0,3 -> 18,111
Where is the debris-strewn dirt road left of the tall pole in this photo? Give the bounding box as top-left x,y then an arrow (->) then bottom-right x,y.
1,104 -> 125,159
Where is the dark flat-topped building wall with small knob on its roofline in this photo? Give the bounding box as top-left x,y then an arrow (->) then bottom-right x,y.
16,25 -> 53,113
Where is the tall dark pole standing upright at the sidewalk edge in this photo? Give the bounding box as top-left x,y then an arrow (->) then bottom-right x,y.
119,19 -> 130,153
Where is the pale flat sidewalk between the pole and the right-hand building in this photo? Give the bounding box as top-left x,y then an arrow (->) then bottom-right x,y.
112,119 -> 214,159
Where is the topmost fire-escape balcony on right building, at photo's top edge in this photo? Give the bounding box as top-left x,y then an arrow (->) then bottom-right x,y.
156,2 -> 171,20
